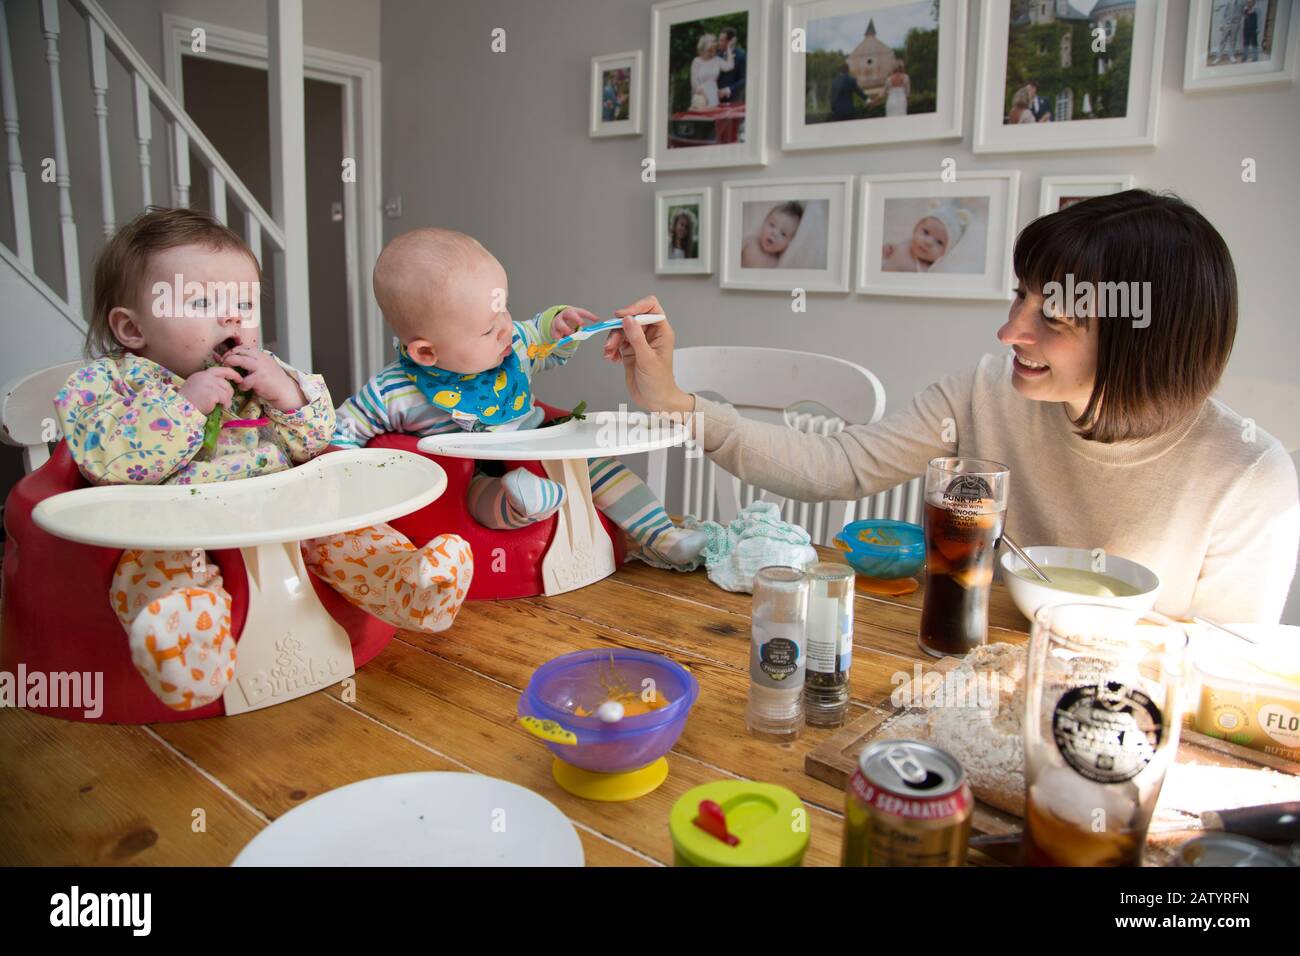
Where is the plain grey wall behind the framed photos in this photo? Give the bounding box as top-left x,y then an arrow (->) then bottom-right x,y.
381,0 -> 1300,427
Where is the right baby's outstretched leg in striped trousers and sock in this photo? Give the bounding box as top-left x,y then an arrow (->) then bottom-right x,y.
588,458 -> 707,571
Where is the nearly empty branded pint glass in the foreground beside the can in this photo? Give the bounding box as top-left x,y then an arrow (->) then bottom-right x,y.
1021,604 -> 1187,866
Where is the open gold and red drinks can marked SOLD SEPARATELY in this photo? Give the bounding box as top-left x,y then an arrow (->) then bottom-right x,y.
840,740 -> 975,866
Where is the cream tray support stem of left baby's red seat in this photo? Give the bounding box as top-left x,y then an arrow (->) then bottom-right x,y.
222,541 -> 356,715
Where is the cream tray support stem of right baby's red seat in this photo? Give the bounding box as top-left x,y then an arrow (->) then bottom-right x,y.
542,458 -> 618,594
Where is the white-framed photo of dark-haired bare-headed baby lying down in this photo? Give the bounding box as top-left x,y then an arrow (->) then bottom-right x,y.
720,176 -> 853,294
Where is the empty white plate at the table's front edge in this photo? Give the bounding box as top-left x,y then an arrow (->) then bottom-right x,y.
233,773 -> 584,866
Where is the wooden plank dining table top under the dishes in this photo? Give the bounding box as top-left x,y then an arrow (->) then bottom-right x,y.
0,549 -> 1050,866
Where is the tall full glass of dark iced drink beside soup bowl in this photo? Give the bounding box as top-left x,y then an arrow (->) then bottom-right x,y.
920,458 -> 1010,657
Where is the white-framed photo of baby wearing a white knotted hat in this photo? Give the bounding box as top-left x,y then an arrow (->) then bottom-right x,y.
858,170 -> 1021,299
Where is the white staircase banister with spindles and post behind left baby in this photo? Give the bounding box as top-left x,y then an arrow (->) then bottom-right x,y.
0,0 -> 311,384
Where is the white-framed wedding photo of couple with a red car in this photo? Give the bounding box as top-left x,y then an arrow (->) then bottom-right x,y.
649,0 -> 771,172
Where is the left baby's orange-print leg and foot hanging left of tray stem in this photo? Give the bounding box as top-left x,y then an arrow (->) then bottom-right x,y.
109,550 -> 235,710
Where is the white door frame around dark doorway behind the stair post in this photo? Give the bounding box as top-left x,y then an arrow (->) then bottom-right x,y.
163,13 -> 384,390
